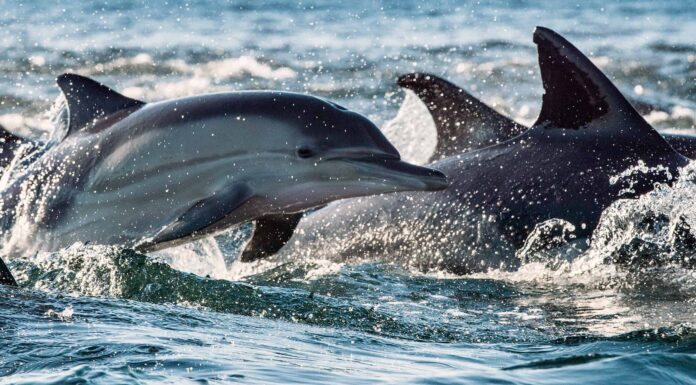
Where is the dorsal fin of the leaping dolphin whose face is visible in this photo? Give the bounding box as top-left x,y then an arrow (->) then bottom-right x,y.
56,73 -> 145,135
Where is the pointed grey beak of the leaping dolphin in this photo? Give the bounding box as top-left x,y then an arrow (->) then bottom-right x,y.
343,157 -> 449,191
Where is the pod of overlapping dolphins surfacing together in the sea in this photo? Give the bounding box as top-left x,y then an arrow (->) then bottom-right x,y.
0,27 -> 693,281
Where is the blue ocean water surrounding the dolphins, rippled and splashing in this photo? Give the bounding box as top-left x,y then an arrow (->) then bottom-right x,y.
0,0 -> 696,384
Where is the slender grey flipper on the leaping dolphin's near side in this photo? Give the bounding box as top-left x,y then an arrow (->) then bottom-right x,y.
136,184 -> 254,251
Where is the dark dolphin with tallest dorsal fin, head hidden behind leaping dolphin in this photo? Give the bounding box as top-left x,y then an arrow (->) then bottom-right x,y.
245,27 -> 688,274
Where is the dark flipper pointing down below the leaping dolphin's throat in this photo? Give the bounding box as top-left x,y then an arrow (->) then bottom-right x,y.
240,213 -> 304,262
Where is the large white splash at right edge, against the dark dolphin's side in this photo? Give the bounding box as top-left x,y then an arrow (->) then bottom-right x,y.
494,164 -> 696,299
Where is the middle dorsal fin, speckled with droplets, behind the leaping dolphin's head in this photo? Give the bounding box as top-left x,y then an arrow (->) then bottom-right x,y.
397,73 -> 526,160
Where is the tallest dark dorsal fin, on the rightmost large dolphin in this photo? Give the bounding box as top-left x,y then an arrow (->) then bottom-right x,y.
534,27 -> 654,133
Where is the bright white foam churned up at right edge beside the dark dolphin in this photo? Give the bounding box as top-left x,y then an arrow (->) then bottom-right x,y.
482,163 -> 696,298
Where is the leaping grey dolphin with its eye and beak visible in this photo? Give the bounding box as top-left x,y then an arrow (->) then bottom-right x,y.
0,74 -> 447,284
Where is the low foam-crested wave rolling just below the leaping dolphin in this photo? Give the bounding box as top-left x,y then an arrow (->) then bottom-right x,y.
10,244 -> 468,342
